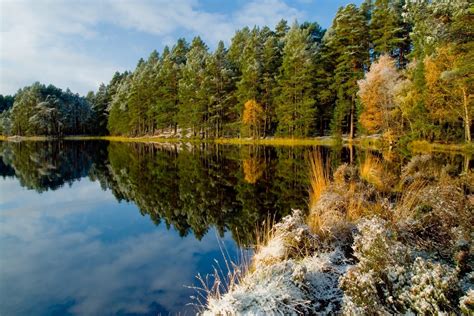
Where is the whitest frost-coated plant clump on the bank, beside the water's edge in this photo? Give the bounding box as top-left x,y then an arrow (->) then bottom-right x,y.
204,211 -> 348,315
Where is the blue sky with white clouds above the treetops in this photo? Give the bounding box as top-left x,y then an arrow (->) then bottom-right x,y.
0,0 -> 362,95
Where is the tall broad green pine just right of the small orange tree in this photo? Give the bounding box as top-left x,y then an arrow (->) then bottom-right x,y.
276,23 -> 315,137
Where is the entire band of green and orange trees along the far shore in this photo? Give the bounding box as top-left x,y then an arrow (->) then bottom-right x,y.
0,0 -> 474,142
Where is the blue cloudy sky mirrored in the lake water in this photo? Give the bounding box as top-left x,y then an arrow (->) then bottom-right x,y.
0,178 -> 235,315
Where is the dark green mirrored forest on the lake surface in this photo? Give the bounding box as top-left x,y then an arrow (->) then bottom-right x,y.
0,140 -> 471,246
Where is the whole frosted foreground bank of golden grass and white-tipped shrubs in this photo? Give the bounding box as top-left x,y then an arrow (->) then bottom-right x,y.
199,153 -> 474,315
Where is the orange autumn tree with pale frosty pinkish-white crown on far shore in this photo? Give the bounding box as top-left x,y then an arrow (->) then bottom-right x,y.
358,55 -> 400,134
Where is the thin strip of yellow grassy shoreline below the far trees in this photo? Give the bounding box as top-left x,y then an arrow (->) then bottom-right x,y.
0,135 -> 474,153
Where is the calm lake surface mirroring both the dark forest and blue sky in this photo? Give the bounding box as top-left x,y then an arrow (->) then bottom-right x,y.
0,141 -> 470,315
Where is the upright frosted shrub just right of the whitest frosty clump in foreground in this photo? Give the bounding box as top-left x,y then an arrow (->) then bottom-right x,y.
340,218 -> 409,315
